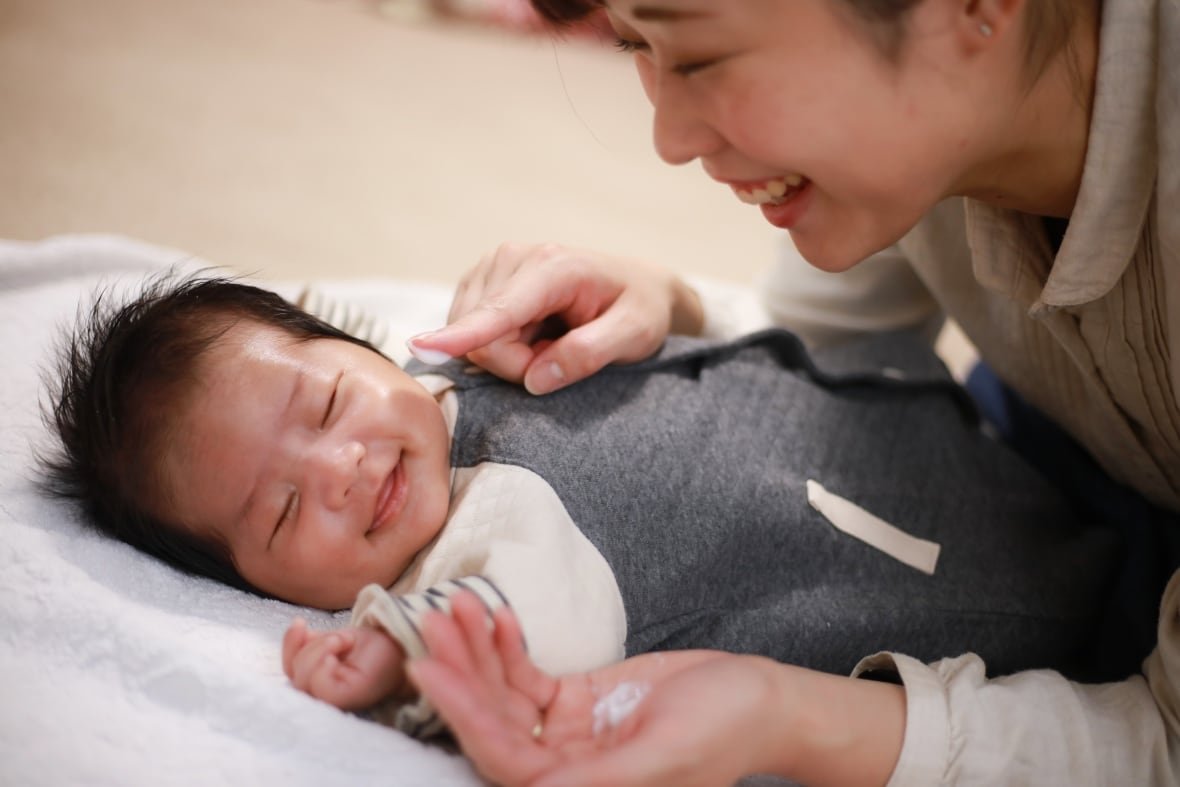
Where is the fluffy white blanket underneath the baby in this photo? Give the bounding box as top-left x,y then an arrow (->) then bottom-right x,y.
0,236 -> 481,787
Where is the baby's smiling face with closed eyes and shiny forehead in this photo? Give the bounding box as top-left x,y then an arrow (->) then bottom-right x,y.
164,321 -> 450,609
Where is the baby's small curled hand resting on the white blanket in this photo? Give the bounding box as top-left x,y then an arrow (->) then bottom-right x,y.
283,618 -> 411,710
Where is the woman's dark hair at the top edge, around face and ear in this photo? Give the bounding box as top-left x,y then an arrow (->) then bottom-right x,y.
531,0 -> 1100,81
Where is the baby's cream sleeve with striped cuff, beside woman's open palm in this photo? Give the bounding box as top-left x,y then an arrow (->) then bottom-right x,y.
352,463 -> 627,737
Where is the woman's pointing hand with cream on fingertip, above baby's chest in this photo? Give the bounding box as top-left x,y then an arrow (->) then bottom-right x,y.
409,244 -> 703,394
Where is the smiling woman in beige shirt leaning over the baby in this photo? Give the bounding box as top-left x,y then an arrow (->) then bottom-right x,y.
413,0 -> 1180,785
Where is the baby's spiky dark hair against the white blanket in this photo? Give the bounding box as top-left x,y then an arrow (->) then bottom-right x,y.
40,273 -> 379,595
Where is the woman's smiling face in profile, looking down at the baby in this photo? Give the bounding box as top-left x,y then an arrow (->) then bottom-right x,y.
608,0 -> 979,271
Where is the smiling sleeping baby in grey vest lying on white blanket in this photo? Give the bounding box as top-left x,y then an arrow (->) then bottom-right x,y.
47,277 -> 1112,736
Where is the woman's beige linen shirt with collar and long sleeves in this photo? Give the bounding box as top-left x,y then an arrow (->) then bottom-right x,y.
745,0 -> 1180,786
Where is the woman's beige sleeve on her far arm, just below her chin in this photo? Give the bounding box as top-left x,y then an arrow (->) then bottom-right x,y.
760,232 -> 942,347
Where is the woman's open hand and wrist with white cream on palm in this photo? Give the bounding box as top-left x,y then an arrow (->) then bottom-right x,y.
408,593 -> 905,787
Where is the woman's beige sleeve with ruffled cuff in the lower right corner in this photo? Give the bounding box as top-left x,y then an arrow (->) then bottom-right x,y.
854,572 -> 1180,787
